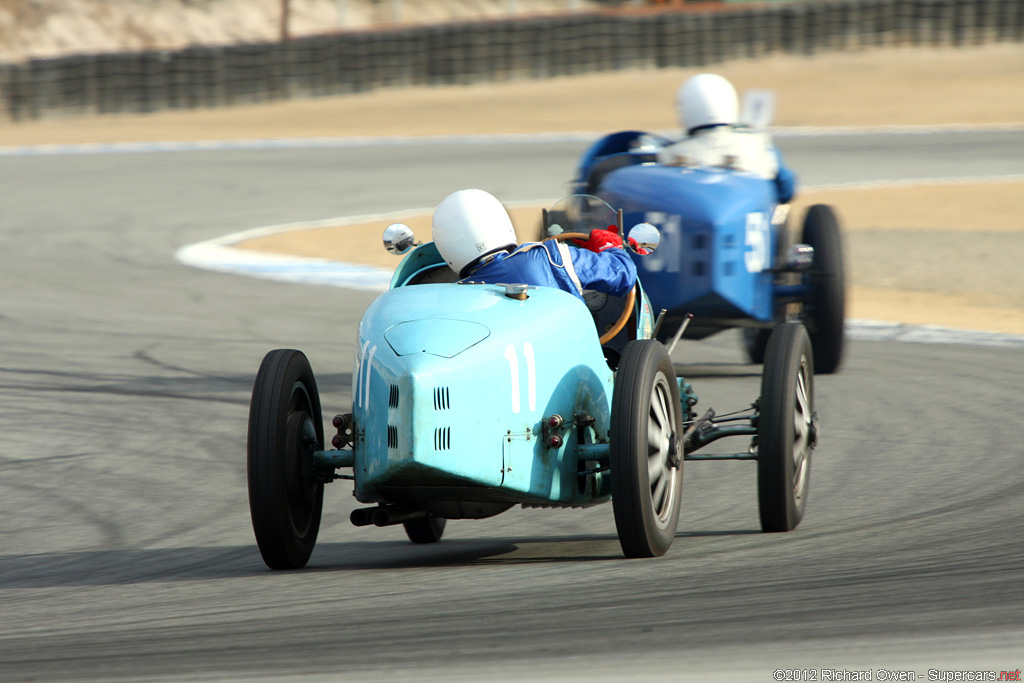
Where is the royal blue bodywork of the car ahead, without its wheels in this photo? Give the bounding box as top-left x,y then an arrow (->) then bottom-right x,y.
577,131 -> 782,338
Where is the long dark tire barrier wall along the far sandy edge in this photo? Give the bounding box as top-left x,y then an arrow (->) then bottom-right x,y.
0,0 -> 1024,121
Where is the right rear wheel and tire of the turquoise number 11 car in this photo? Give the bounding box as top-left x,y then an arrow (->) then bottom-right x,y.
610,340 -> 683,557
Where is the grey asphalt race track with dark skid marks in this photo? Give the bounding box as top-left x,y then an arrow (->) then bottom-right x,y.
0,131 -> 1024,681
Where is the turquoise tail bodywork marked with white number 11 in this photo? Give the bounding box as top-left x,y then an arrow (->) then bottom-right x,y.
353,274 -> 614,505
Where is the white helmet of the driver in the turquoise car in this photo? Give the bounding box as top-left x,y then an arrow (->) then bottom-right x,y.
432,189 -> 516,276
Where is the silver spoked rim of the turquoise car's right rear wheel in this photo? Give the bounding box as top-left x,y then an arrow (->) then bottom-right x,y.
647,374 -> 679,528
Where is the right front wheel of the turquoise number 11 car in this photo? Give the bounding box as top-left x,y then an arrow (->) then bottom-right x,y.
758,323 -> 817,531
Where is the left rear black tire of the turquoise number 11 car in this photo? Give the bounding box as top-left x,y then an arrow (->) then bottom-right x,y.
248,349 -> 324,569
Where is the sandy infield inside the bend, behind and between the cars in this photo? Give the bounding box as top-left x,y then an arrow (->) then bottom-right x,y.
241,182 -> 1024,334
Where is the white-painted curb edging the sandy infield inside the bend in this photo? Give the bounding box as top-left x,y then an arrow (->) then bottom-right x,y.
174,205 -> 1024,348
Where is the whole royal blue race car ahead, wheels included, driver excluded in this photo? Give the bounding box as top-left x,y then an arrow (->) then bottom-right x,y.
573,131 -> 846,373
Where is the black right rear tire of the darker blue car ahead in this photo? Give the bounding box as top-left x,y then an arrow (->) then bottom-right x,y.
802,204 -> 846,375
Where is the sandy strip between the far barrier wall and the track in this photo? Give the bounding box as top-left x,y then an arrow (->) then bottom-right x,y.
0,43 -> 1024,141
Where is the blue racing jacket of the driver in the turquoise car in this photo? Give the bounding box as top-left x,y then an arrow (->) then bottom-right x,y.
461,240 -> 637,301
